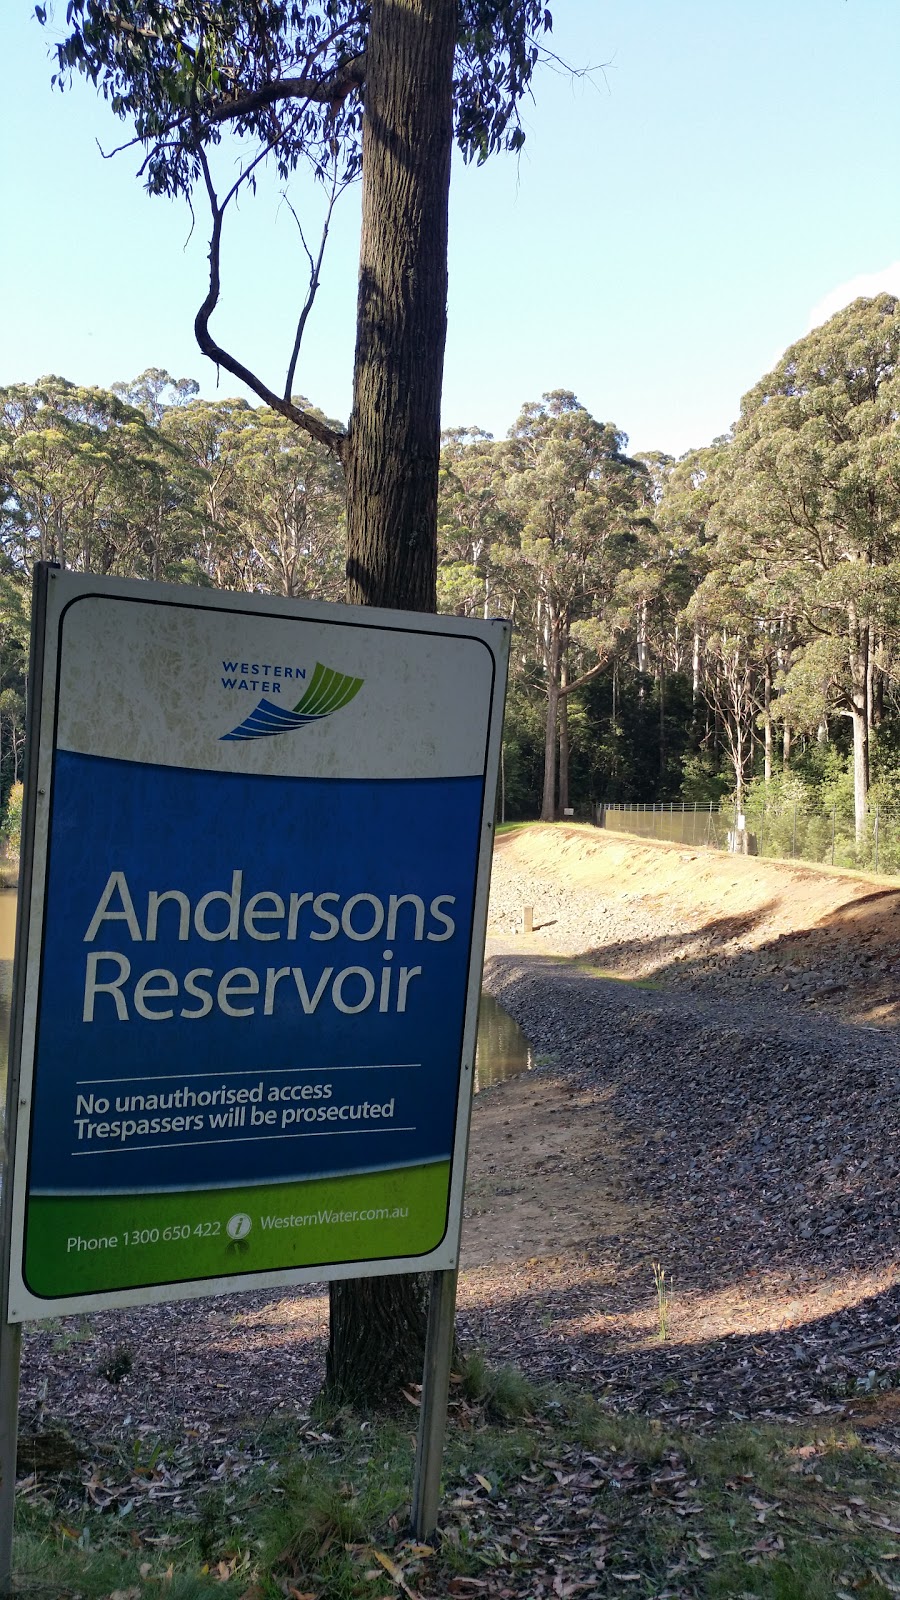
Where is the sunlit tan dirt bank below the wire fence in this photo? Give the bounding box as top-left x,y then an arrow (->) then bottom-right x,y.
490,826 -> 900,1027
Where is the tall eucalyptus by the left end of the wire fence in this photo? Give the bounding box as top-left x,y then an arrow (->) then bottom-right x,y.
503,389 -> 645,821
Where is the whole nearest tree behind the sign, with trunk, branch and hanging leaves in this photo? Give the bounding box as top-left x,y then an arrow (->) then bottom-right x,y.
49,0 -> 551,1398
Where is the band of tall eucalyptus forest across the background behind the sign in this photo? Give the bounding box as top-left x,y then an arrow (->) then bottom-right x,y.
0,294 -> 900,862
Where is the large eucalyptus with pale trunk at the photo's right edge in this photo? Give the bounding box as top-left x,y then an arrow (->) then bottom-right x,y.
704,294 -> 900,837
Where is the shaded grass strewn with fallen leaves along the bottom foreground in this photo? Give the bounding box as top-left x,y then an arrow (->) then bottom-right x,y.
16,1376 -> 900,1600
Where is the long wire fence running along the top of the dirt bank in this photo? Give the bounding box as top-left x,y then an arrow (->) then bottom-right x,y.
594,800 -> 900,874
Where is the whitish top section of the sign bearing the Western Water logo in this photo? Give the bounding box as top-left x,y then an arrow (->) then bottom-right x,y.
50,573 -> 493,779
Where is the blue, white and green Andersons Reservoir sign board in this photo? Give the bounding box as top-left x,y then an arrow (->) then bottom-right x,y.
10,571 -> 509,1322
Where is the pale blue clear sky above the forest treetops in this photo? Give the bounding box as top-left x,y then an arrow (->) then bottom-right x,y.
0,0 -> 900,456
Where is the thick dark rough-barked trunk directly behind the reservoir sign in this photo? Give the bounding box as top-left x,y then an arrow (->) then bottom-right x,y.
325,0 -> 456,1406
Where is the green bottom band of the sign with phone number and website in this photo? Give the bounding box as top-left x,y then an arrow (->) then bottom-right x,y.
24,1162 -> 450,1299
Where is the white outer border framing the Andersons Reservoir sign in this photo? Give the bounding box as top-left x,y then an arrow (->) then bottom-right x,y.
0,565 -> 511,1325
